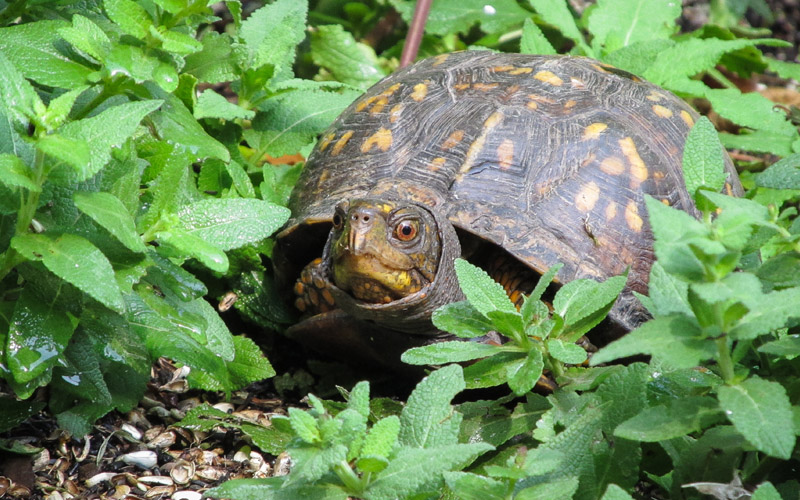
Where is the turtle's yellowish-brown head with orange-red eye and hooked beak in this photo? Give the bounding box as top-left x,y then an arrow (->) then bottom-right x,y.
329,199 -> 442,304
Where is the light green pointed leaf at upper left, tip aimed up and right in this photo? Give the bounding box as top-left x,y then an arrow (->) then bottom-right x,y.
59,101 -> 161,181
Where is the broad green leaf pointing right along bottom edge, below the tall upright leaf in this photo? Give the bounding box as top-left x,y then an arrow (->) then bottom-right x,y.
365,443 -> 492,500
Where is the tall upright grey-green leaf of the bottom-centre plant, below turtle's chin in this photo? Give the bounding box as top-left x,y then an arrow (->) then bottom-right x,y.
404,365 -> 464,450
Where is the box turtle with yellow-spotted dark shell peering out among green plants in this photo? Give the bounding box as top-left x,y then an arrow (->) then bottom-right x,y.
275,51 -> 742,361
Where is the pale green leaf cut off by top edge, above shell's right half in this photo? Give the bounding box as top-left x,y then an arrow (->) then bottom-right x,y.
588,0 -> 681,51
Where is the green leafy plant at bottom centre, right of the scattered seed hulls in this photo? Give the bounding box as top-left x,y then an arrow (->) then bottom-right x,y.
206,365 -> 492,499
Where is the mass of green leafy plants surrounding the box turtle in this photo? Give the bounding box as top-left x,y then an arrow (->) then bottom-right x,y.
0,0 -> 800,499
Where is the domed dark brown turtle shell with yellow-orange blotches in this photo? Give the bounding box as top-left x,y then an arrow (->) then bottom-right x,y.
280,52 -> 742,327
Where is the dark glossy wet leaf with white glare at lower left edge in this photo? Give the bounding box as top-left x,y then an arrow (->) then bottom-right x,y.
3,286 -> 76,382
